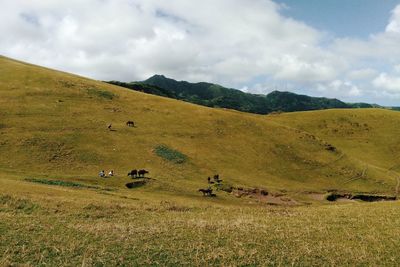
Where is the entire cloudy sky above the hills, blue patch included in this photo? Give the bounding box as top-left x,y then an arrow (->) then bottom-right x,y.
0,0 -> 400,106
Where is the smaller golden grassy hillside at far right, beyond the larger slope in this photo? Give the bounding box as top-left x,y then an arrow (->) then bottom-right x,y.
271,109 -> 400,189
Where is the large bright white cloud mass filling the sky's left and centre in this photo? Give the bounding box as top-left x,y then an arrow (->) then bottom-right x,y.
0,0 -> 338,84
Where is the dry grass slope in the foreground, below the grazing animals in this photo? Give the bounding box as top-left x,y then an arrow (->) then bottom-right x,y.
0,179 -> 400,266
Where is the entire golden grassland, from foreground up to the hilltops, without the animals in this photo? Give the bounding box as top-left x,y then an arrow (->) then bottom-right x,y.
0,57 -> 400,266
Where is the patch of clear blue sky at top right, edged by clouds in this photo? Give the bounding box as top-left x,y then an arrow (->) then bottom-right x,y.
277,0 -> 400,38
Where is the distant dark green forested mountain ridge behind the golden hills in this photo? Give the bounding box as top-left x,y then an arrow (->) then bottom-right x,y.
109,75 -> 379,114
